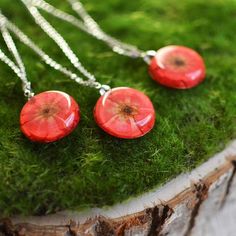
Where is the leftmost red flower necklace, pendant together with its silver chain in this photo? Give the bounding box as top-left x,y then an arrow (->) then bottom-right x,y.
0,13 -> 80,143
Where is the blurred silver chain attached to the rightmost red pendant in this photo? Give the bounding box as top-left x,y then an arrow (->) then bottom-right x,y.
22,0 -> 156,63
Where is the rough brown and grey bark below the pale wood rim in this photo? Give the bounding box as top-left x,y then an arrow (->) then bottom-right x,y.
0,146 -> 236,236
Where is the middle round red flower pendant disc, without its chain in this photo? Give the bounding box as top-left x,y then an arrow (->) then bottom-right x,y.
94,87 -> 155,139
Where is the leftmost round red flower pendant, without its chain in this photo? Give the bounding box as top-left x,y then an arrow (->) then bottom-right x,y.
20,91 -> 80,143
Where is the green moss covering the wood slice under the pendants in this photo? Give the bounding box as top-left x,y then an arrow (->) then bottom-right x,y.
0,0 -> 236,215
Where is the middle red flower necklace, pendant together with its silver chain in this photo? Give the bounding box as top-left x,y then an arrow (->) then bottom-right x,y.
1,11 -> 155,139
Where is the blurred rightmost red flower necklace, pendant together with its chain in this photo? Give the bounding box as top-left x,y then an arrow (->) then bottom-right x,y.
22,0 -> 206,89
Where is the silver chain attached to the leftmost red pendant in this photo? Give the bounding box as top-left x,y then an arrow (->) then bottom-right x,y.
0,12 -> 34,99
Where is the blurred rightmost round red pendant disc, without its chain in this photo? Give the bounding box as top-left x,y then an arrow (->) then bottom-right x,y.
149,46 -> 206,89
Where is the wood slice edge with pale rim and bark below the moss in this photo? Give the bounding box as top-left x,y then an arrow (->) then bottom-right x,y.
0,142 -> 236,236
